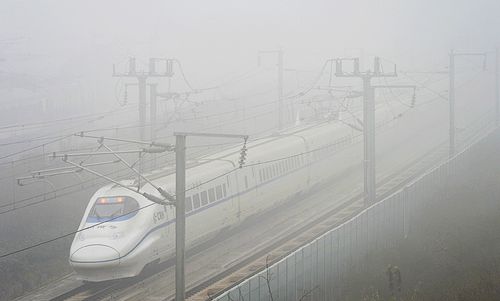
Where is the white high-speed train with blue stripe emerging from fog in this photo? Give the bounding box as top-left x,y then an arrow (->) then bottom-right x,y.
69,102 -> 404,281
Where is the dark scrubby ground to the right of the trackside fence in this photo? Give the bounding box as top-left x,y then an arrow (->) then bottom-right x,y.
343,135 -> 500,301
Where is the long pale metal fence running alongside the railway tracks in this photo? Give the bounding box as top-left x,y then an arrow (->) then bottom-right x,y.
214,127 -> 494,301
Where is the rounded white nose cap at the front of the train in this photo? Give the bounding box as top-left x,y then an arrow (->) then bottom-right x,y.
70,244 -> 120,266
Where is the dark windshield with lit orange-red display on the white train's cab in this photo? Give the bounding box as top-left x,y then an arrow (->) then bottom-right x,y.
87,196 -> 139,222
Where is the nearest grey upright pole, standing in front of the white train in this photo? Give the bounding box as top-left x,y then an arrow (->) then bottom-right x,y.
175,135 -> 186,301
